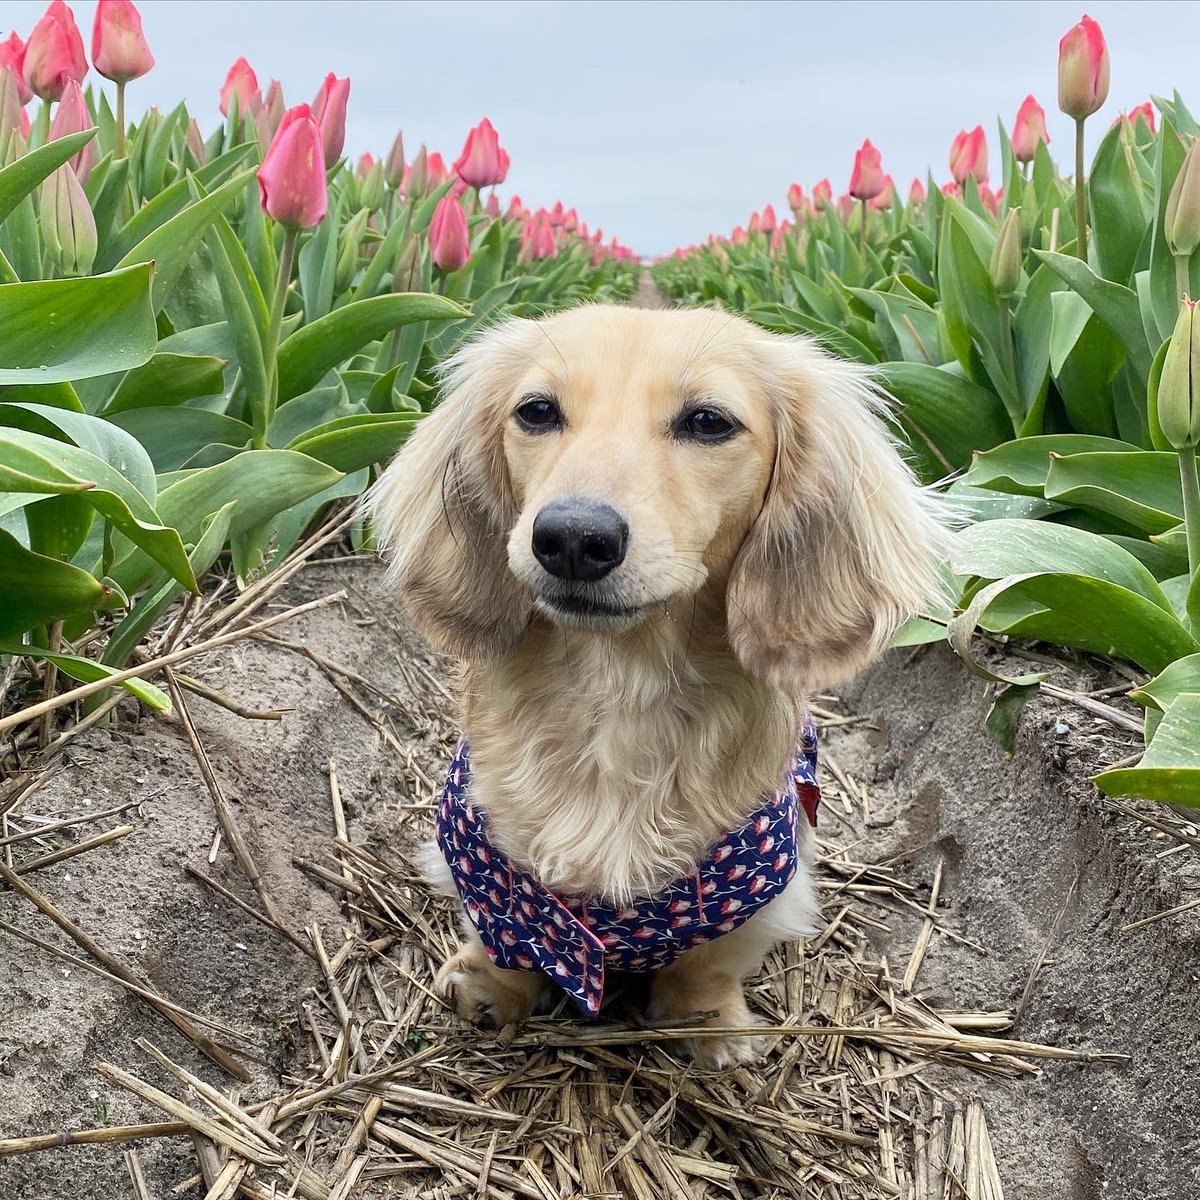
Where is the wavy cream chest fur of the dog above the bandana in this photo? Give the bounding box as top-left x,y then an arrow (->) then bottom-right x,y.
466,620 -> 797,900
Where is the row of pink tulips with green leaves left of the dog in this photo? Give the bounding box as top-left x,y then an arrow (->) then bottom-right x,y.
0,7 -> 638,739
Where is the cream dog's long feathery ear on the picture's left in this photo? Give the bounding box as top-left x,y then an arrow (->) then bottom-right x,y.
367,319 -> 534,659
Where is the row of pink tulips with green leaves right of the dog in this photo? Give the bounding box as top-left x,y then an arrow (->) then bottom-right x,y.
654,18 -> 1200,804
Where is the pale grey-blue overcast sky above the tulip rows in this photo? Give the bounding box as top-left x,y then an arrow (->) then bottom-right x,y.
7,0 -> 1200,254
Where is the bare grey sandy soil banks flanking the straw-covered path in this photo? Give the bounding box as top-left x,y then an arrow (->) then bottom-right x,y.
0,564 -> 1200,1200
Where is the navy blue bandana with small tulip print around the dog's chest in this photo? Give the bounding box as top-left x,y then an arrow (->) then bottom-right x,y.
437,720 -> 821,1016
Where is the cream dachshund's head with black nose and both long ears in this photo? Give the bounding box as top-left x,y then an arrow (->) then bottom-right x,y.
371,306 -> 942,691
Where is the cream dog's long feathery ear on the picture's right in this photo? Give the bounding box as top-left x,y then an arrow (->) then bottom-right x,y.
727,335 -> 949,695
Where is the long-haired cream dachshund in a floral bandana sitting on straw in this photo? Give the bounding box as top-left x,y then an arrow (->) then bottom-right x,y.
368,305 -> 947,1068
